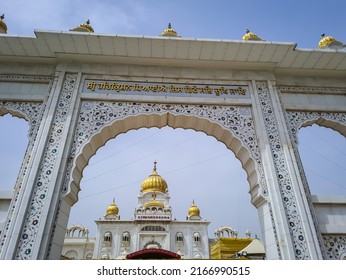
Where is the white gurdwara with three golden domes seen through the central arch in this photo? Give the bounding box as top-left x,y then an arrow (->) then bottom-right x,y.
63,162 -> 210,259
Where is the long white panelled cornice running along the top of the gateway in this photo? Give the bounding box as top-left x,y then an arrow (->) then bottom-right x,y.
0,30 -> 346,72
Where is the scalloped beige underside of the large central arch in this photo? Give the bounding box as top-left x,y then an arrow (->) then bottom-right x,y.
70,113 -> 260,202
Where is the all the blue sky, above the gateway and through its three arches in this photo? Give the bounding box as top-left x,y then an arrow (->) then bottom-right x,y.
0,0 -> 346,240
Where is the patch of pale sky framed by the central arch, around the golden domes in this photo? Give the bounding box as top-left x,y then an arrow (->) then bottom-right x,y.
69,127 -> 261,243
